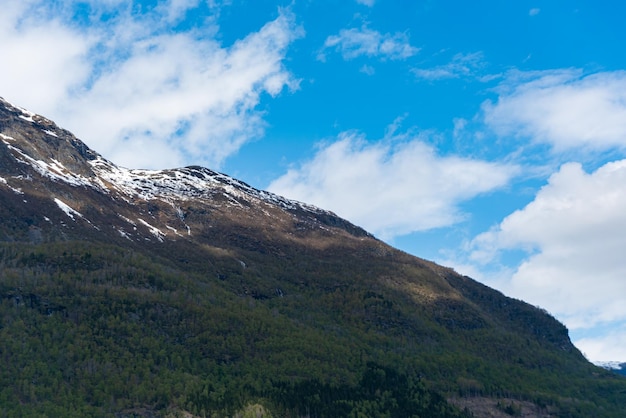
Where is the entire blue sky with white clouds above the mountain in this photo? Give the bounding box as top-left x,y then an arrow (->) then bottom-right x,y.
0,0 -> 626,361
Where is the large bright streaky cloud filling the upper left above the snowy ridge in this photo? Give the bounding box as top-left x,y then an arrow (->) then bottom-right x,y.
0,0 -> 301,167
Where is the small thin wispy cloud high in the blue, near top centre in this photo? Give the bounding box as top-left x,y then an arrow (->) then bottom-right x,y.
318,26 -> 419,61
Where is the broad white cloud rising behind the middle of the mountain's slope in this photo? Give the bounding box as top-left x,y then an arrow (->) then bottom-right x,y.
269,133 -> 515,239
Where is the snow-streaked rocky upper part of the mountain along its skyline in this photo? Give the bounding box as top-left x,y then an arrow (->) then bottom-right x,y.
0,95 -> 369,242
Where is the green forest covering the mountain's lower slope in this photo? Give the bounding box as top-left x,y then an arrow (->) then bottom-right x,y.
0,242 -> 626,417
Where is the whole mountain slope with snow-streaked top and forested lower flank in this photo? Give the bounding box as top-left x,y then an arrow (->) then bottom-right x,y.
0,95 -> 626,417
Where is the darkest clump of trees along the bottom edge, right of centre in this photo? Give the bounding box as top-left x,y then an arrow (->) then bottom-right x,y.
187,363 -> 471,418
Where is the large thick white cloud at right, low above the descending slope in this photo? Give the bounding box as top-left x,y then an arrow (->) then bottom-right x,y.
472,160 -> 626,329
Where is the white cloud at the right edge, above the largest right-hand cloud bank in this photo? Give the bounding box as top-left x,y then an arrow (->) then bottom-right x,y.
483,70 -> 626,151
